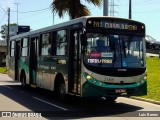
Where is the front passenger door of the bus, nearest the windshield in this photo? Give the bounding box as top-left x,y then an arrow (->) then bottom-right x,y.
68,29 -> 81,95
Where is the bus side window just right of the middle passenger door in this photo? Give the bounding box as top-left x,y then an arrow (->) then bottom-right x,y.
41,33 -> 51,56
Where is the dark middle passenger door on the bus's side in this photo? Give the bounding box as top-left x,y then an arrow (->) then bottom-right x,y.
29,37 -> 38,85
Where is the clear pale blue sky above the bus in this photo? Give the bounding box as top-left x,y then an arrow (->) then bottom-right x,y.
0,0 -> 160,41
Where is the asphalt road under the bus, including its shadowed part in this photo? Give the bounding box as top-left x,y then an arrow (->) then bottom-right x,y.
0,74 -> 160,120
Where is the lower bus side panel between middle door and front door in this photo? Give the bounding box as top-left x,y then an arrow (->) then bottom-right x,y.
36,57 -> 67,91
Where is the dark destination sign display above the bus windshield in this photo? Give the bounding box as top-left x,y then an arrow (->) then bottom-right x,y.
87,18 -> 144,31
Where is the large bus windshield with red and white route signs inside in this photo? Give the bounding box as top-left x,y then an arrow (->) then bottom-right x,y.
84,33 -> 145,68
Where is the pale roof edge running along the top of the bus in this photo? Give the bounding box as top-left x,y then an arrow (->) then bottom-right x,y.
10,16 -> 143,40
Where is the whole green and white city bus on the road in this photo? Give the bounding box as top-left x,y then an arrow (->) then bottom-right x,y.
8,16 -> 147,101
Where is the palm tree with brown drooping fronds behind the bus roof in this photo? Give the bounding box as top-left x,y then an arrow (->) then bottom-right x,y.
51,0 -> 102,19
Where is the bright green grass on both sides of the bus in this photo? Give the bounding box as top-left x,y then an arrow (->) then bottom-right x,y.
0,57 -> 160,101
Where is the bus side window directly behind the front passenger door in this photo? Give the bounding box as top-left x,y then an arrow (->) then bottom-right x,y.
56,30 -> 67,55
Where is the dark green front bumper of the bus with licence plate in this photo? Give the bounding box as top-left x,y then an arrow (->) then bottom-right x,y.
82,74 -> 147,97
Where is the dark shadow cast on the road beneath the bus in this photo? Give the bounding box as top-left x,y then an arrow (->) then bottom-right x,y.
0,85 -> 143,119
